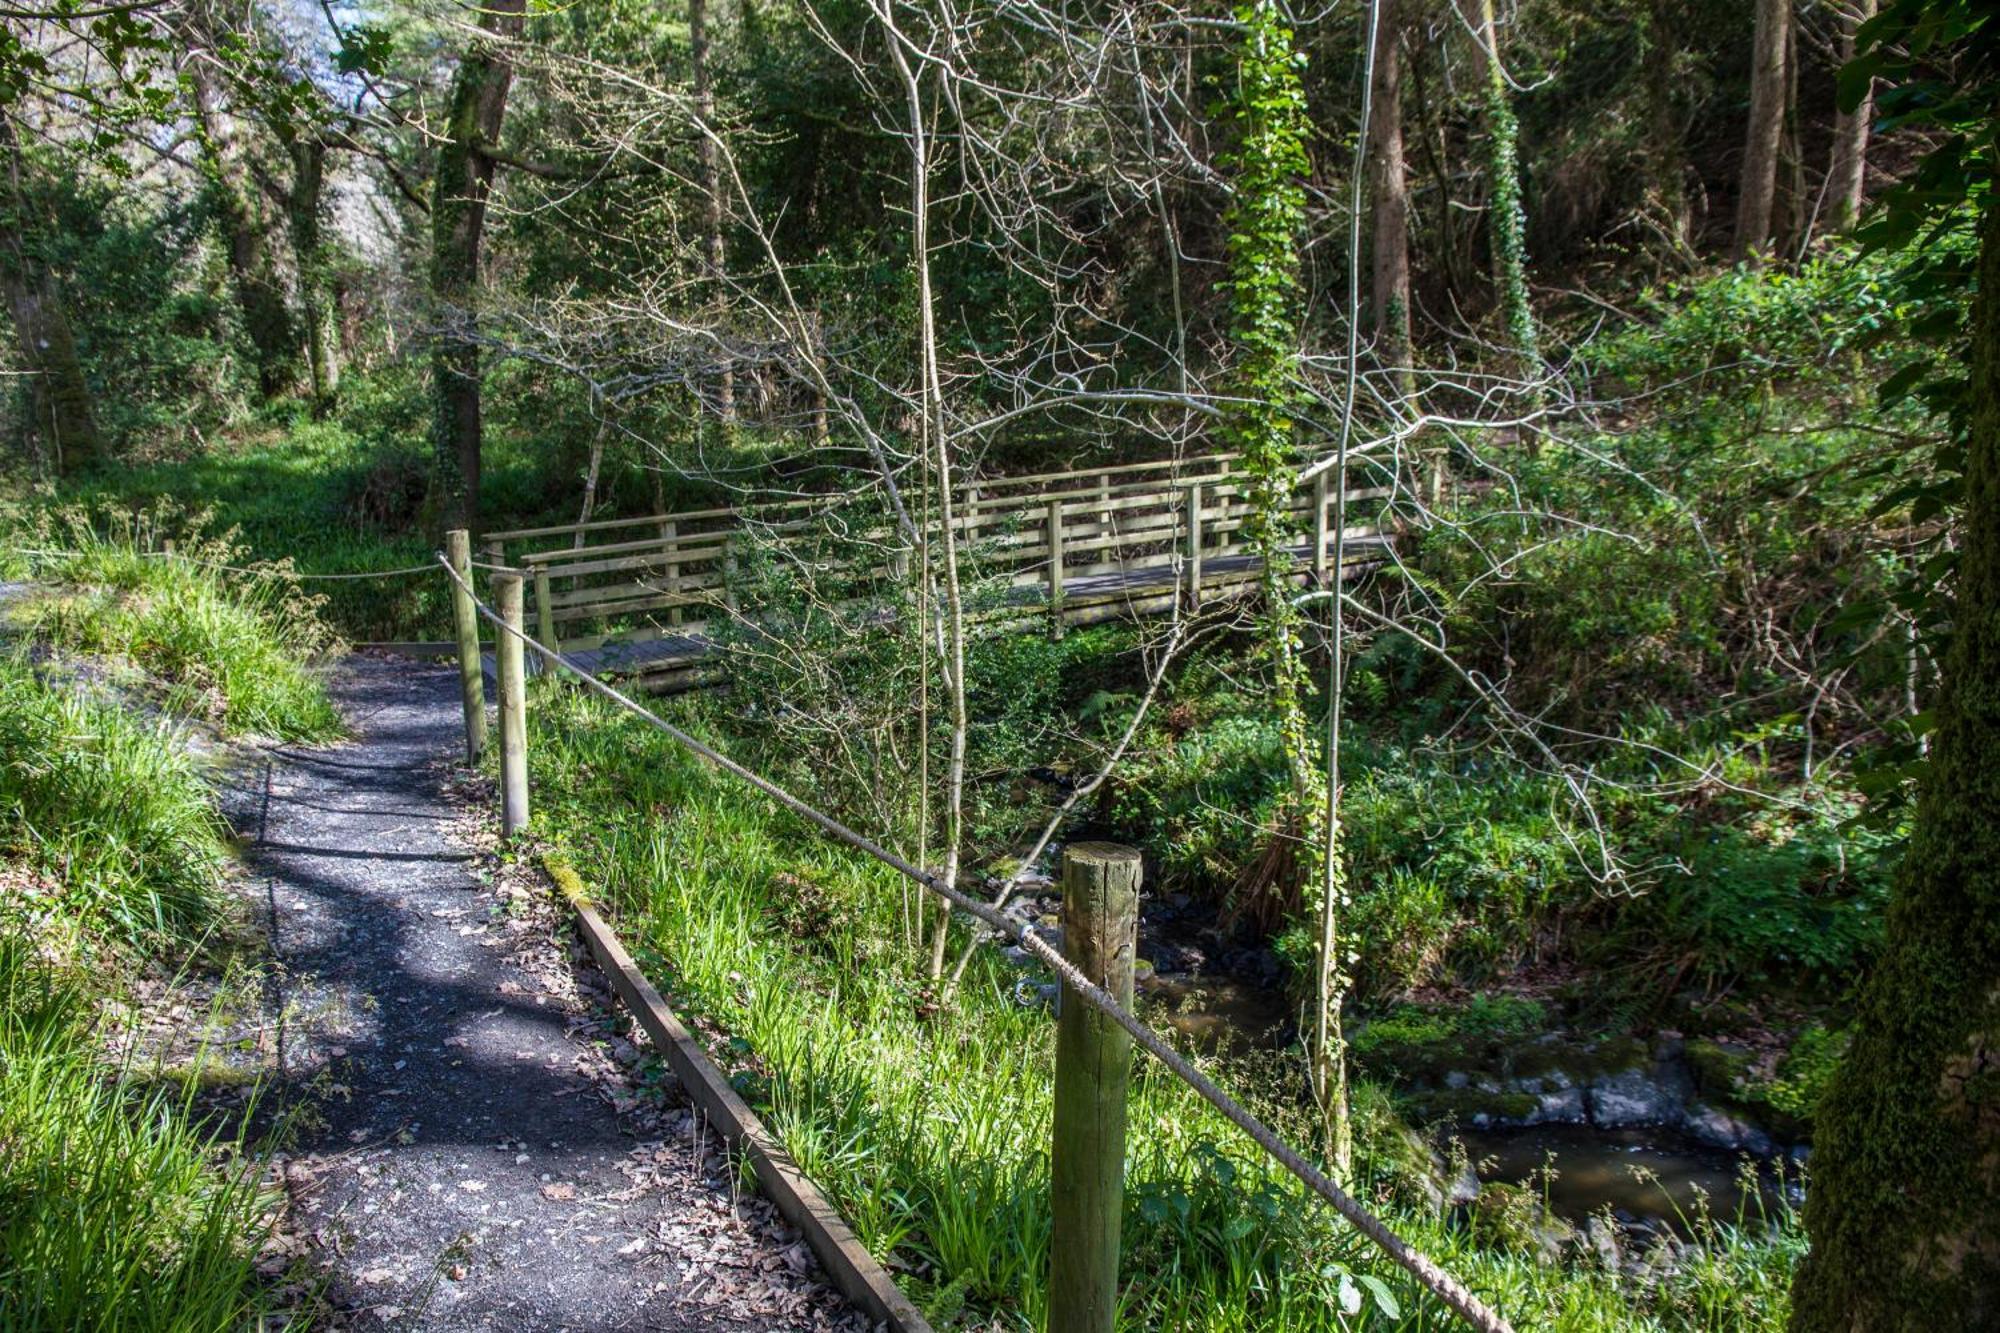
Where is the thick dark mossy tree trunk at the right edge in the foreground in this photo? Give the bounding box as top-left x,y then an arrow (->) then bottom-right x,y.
1792,200 -> 2000,1333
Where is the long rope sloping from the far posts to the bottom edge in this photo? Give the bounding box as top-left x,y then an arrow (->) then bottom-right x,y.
436,552 -> 1512,1333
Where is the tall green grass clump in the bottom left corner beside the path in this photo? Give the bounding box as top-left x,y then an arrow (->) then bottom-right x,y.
0,935 -> 274,1333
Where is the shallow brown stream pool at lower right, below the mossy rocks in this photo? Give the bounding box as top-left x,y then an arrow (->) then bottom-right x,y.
1454,1125 -> 1782,1233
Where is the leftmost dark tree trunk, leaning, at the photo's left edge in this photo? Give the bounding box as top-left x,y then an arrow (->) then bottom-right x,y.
0,116 -> 108,472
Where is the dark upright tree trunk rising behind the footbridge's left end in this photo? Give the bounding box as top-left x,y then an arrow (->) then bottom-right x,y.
430,0 -> 528,530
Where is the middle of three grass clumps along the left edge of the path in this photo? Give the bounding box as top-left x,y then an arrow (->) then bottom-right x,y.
0,658 -> 224,945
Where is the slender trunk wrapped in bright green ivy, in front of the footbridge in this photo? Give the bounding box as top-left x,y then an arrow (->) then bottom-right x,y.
1224,0 -> 1352,1173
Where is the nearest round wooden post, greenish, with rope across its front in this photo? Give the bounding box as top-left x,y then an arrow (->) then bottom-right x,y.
1048,843 -> 1140,1333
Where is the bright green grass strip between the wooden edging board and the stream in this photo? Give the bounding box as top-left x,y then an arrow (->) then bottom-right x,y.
530,689 -> 1804,1331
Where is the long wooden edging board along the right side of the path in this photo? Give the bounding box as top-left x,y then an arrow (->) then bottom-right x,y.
546,865 -> 932,1333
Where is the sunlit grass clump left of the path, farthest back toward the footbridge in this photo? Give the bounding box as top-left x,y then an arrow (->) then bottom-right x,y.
18,510 -> 340,741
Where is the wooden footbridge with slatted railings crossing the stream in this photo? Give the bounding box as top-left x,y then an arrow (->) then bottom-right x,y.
484,454 -> 1392,689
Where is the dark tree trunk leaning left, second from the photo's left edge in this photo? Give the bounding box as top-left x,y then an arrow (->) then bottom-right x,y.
188,59 -> 298,400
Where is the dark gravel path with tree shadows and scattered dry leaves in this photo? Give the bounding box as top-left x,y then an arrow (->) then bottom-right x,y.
226,656 -> 868,1333
